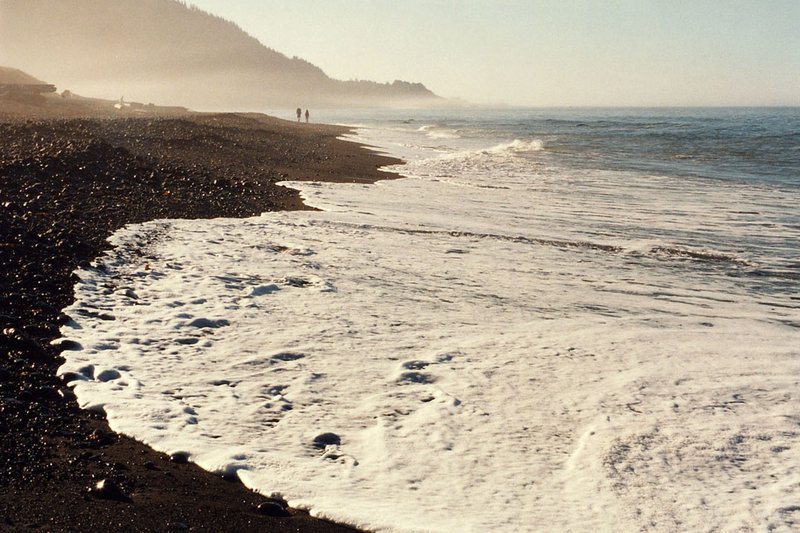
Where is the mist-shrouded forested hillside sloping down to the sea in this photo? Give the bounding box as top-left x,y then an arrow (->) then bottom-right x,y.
0,0 -> 440,109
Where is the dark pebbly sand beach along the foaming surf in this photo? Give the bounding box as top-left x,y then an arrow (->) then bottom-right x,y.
0,100 -> 396,532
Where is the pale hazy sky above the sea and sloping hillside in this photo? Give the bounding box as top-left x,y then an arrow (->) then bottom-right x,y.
189,0 -> 800,106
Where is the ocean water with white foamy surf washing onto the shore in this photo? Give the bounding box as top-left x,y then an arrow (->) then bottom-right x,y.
60,109 -> 800,532
